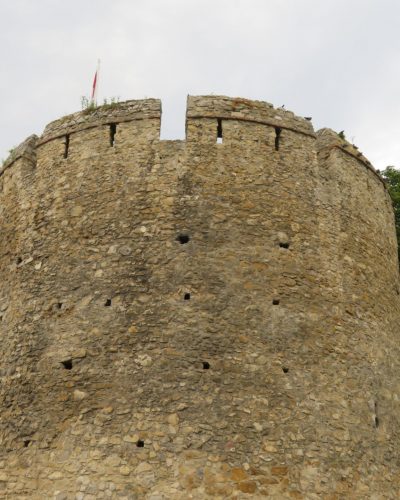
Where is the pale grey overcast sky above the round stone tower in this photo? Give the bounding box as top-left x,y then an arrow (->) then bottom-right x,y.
0,0 -> 400,169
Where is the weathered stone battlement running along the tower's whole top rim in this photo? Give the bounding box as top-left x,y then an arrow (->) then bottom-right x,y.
0,95 -> 385,188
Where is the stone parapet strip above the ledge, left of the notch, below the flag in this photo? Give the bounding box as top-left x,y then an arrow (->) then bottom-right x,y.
39,99 -> 161,144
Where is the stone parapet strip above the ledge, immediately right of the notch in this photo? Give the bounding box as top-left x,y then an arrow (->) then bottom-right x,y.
186,96 -> 315,137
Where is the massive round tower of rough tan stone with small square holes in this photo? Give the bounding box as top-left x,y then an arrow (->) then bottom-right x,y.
0,96 -> 400,500
